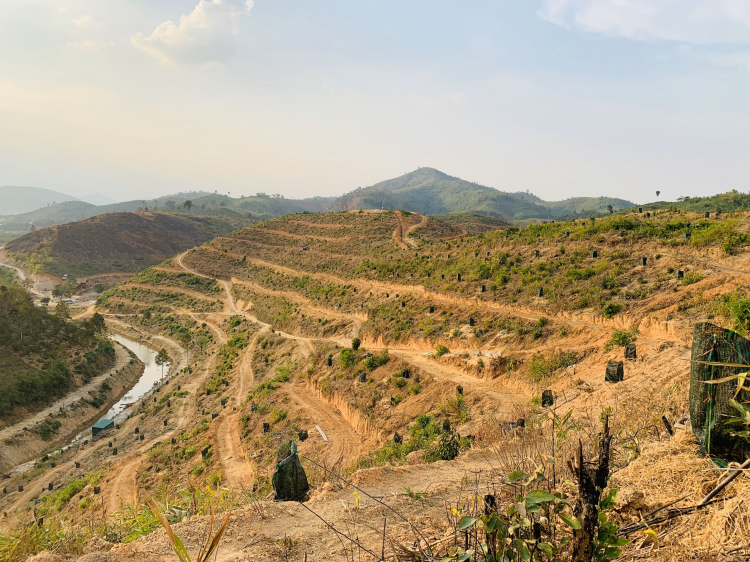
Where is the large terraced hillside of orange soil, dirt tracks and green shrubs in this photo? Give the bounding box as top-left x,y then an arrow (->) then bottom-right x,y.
0,211 -> 750,561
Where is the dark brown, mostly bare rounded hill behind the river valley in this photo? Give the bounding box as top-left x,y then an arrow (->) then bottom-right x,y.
6,213 -> 252,277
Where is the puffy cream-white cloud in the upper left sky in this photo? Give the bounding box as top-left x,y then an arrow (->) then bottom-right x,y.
131,0 -> 253,64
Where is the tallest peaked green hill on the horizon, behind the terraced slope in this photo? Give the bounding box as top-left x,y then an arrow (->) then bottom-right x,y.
333,168 -> 634,220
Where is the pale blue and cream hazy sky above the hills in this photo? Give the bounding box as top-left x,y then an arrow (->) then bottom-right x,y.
0,0 -> 750,203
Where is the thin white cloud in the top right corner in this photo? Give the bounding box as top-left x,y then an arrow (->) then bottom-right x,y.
539,0 -> 750,45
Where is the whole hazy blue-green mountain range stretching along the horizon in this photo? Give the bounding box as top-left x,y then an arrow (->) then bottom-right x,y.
0,168 -> 634,237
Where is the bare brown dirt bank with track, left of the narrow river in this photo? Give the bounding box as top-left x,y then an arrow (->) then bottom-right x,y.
0,345 -> 144,472
